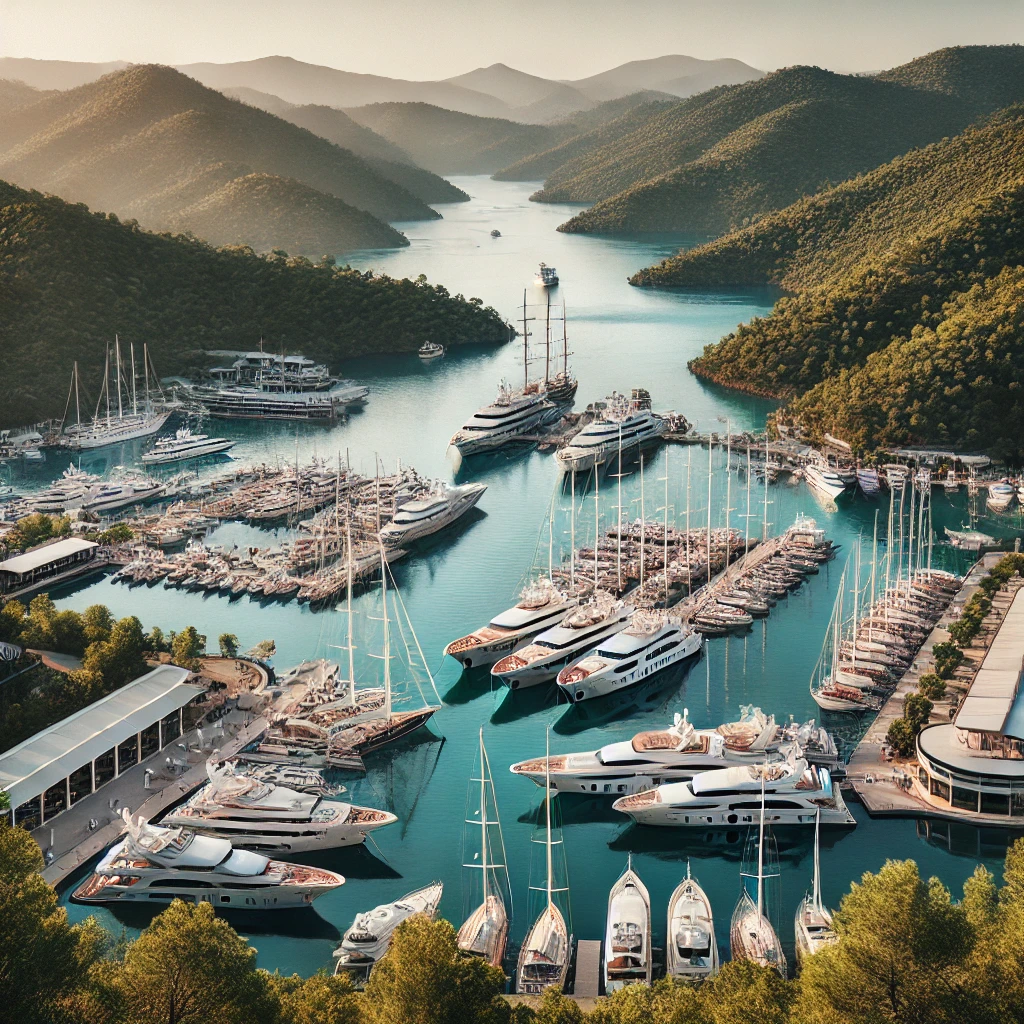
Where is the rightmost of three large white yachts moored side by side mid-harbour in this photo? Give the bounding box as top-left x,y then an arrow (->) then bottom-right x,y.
558,610 -> 703,702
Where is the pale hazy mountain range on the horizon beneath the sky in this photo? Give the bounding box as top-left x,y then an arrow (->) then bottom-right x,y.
0,55 -> 762,124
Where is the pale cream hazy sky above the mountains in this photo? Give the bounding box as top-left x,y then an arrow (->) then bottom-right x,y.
0,0 -> 1024,79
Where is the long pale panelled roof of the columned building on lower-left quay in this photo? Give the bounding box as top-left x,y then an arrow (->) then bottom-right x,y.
0,665 -> 204,807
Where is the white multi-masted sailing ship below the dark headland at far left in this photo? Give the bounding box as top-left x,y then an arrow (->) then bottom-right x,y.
59,335 -> 171,452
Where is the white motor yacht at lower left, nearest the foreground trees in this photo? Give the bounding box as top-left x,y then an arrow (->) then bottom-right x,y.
72,808 -> 345,910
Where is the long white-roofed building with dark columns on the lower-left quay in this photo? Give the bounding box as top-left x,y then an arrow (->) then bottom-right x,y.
0,665 -> 205,830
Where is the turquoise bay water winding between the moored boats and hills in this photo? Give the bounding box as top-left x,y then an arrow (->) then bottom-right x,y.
46,177 -> 1024,974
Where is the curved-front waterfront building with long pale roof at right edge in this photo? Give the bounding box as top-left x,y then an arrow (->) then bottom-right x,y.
915,589 -> 1024,826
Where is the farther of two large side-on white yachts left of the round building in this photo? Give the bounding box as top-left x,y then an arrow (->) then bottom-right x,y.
509,708 -> 840,797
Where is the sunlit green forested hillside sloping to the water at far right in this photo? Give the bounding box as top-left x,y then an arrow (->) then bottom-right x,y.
633,106 -> 1024,454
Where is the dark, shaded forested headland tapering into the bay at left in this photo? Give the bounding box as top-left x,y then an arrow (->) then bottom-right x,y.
0,182 -> 508,427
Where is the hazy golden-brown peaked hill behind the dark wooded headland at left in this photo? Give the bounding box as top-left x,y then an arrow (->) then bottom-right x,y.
0,65 -> 437,255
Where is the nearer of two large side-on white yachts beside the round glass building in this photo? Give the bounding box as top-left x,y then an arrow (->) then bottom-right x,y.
611,752 -> 857,828
